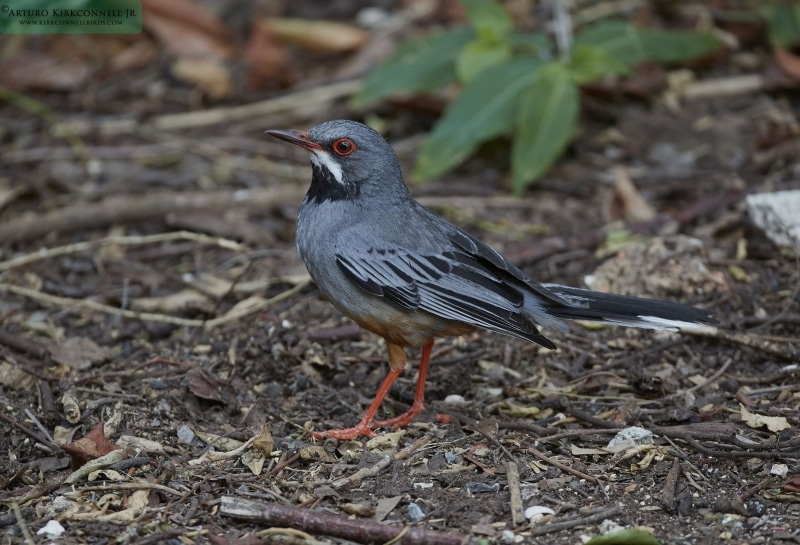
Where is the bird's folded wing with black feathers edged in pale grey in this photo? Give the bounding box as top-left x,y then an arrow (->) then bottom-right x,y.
336,247 -> 552,347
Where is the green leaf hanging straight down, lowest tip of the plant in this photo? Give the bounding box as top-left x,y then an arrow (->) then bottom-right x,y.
511,61 -> 580,195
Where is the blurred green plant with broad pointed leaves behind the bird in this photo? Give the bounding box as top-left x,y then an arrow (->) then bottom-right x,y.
355,0 -> 719,195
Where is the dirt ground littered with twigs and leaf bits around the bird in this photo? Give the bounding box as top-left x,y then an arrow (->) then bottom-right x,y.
0,3 -> 800,545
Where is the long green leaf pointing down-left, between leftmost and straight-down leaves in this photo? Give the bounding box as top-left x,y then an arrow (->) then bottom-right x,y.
414,58 -> 542,180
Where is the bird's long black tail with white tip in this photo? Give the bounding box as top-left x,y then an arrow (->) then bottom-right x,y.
542,284 -> 719,331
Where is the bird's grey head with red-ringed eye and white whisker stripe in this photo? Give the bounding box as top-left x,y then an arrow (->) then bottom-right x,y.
267,119 -> 408,202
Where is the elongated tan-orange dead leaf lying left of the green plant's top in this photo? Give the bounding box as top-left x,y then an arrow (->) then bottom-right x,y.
257,17 -> 369,53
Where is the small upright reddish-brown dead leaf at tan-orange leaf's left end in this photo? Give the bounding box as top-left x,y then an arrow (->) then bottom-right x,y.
244,22 -> 294,90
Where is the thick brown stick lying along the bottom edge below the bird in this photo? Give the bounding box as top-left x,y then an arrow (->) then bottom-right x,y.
219,496 -> 469,545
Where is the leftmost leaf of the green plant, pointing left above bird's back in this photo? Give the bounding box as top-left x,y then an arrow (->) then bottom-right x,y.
354,27 -> 475,107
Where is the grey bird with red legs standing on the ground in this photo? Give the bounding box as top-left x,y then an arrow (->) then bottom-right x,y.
267,120 -> 717,440
